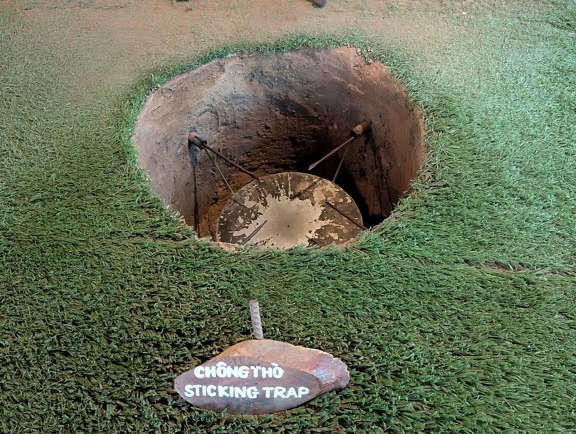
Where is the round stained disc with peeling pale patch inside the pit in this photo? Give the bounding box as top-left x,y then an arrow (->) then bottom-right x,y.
216,172 -> 362,249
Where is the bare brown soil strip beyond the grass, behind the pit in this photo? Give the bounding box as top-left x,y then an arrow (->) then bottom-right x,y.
0,0 -> 468,100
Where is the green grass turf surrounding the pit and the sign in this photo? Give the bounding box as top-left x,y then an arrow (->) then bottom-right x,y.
0,2 -> 576,433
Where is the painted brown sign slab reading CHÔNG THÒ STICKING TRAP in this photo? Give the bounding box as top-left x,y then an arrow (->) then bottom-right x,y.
174,339 -> 349,414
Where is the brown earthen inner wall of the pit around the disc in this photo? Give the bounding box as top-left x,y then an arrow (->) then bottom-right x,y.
132,47 -> 425,250
